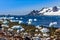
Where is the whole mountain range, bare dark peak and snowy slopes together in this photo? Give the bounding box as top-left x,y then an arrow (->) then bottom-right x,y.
28,6 -> 60,16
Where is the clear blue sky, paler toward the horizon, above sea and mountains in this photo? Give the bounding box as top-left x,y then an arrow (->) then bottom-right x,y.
0,0 -> 60,15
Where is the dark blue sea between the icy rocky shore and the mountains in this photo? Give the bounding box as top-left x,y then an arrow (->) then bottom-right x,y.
0,16 -> 60,28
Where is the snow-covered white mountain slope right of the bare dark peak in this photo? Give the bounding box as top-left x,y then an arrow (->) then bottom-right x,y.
39,6 -> 60,15
